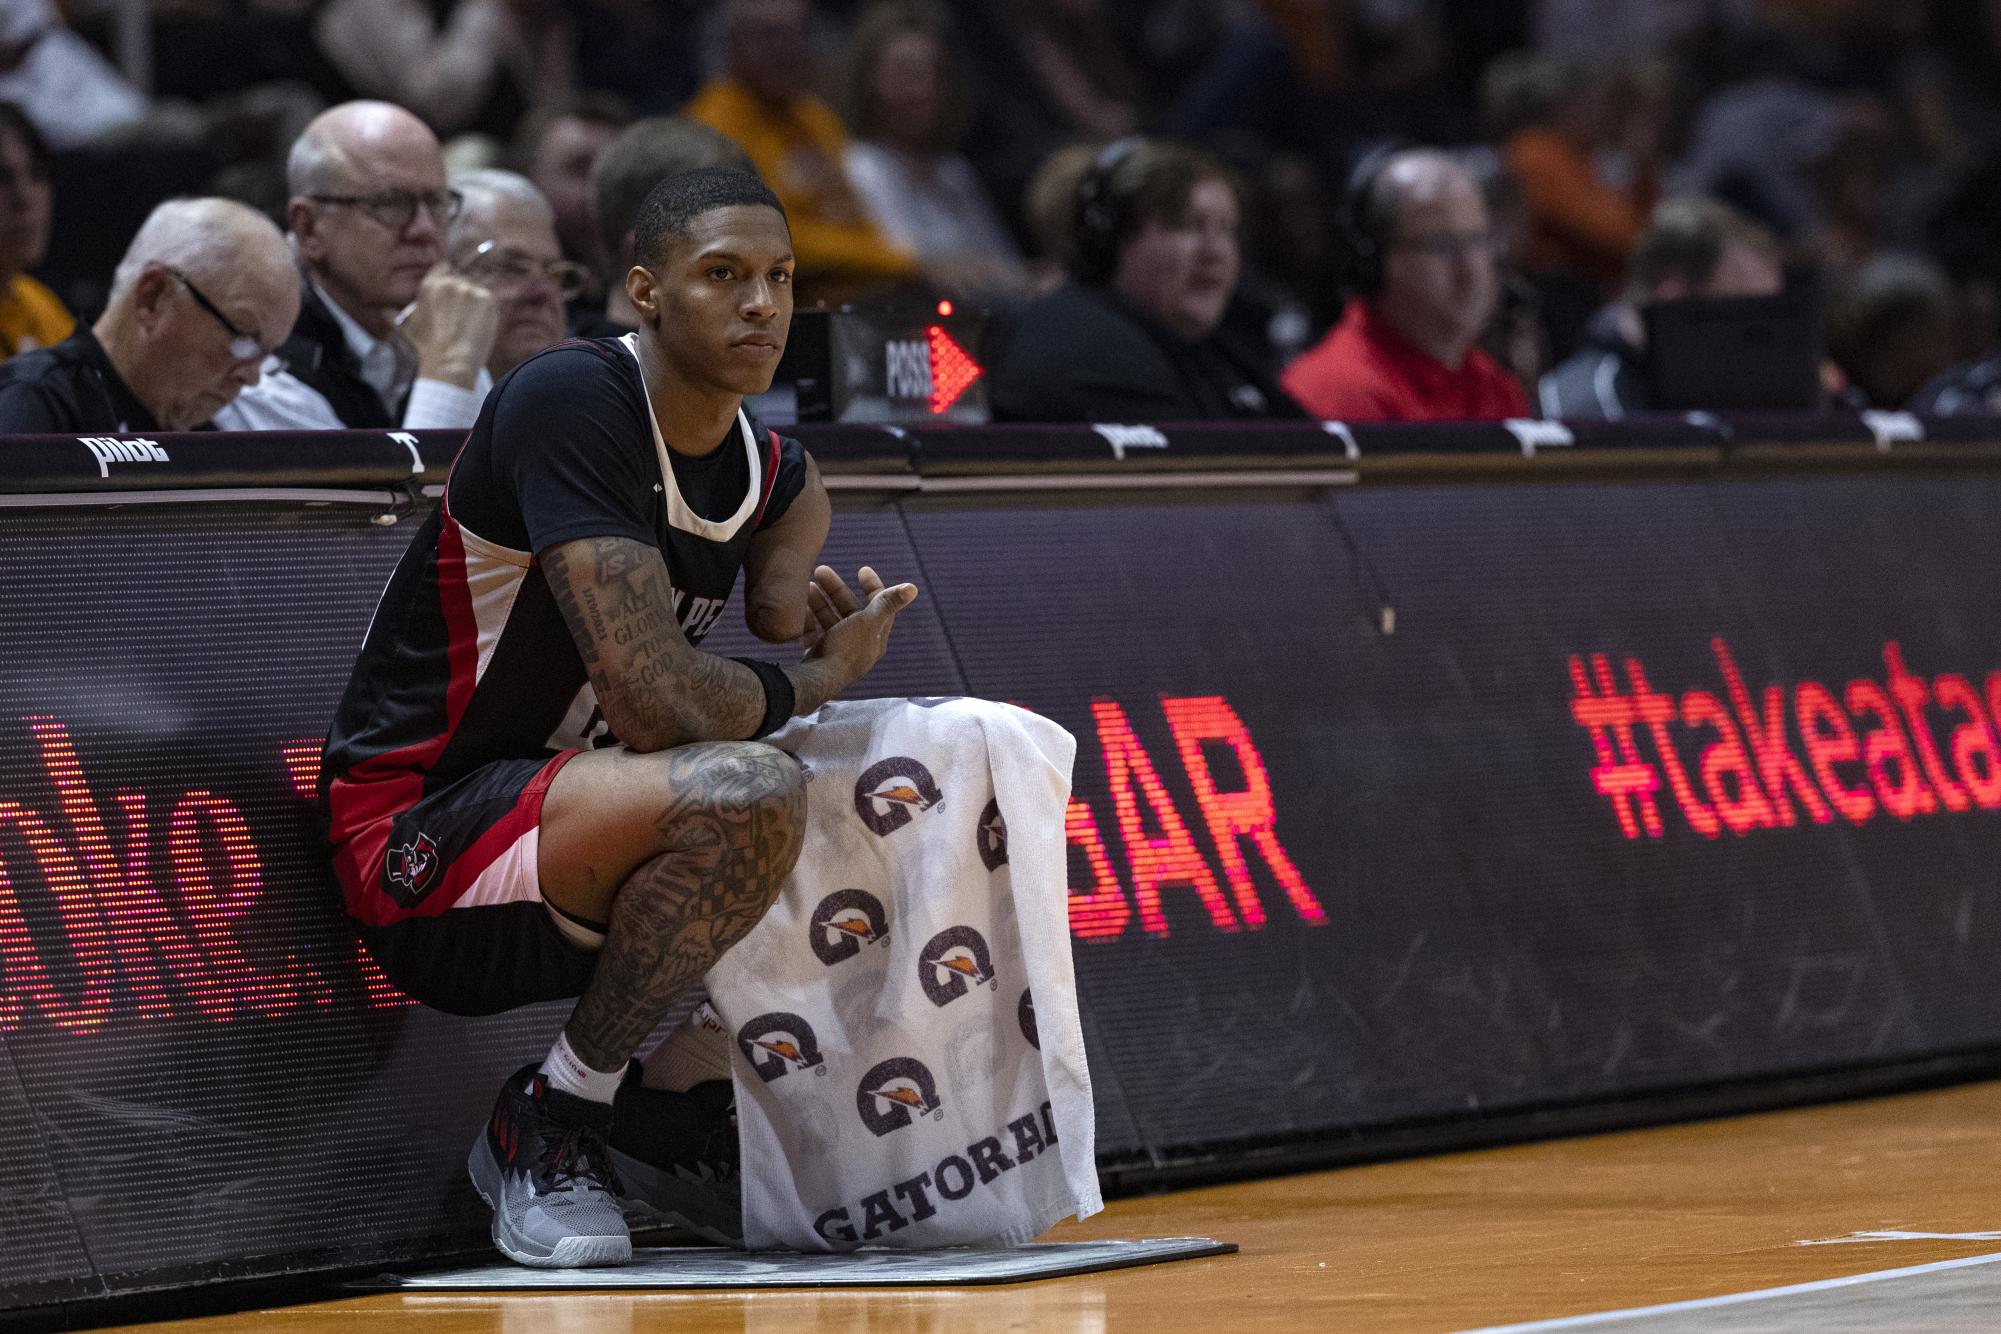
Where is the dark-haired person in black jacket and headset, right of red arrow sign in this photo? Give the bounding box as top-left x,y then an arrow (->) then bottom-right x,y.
988,138 -> 1303,422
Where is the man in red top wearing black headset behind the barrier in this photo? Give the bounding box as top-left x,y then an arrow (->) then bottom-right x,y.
1283,148 -> 1531,422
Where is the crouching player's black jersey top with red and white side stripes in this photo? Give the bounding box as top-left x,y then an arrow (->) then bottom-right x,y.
320,334 -> 806,816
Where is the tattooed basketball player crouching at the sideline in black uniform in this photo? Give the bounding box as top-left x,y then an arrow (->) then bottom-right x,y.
320,170 -> 916,1266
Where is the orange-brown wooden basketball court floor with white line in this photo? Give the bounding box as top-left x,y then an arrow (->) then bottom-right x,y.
97,1082 -> 2001,1334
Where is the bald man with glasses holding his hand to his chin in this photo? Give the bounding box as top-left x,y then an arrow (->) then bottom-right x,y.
216,102 -> 498,430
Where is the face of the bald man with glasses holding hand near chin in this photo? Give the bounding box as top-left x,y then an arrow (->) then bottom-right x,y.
288,116 -> 456,322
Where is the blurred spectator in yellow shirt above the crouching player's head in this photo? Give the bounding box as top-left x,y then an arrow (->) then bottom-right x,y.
682,0 -> 918,302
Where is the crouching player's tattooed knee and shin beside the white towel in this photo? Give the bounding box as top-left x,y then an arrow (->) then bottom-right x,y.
564,742 -> 806,1070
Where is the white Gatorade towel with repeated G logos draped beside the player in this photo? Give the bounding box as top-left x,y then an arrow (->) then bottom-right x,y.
708,700 -> 1103,1250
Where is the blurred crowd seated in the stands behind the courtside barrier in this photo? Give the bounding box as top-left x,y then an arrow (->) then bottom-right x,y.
0,0 -> 2001,432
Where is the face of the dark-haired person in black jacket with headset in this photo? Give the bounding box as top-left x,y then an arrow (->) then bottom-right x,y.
1113,176 -> 1243,342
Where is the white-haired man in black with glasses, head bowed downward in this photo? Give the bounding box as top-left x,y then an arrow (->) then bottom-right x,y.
0,200 -> 298,436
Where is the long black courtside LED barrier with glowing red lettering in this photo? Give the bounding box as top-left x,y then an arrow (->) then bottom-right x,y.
0,418 -> 2001,1318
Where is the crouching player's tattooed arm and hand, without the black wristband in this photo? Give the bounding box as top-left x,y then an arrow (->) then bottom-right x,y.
538,538 -> 916,752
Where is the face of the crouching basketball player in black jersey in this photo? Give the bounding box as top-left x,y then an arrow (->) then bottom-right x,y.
634,204 -> 792,394
